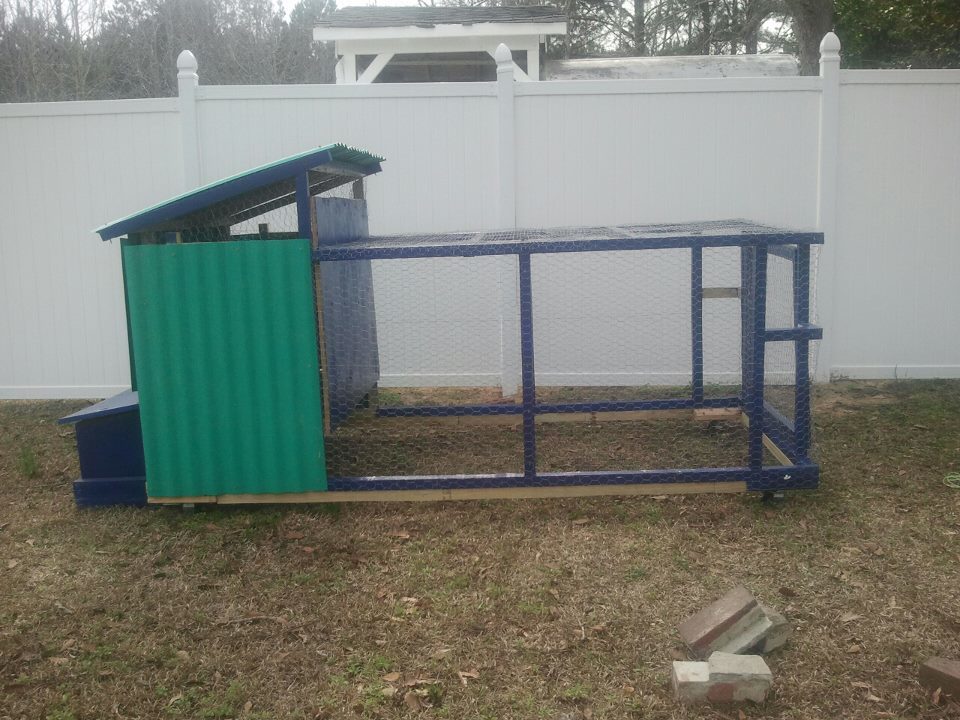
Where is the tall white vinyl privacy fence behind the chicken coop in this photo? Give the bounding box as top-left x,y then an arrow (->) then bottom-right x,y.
0,36 -> 960,398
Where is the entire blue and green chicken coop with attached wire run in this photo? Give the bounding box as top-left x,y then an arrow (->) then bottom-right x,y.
67,145 -> 823,504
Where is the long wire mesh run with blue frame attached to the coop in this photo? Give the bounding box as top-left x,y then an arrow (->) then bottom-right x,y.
315,223 -> 818,490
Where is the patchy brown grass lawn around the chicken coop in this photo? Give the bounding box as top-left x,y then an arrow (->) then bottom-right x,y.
0,382 -> 960,720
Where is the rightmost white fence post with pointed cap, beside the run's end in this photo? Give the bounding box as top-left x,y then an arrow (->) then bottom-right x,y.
814,32 -> 840,382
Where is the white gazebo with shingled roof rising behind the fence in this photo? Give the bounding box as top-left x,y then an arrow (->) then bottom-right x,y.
313,5 -> 567,83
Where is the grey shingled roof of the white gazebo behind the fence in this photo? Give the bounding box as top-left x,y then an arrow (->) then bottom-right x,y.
317,5 -> 567,28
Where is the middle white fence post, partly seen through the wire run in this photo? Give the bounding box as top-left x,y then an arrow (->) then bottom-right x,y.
493,43 -> 521,397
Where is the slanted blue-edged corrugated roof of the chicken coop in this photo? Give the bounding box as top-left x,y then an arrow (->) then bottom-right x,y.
95,143 -> 383,240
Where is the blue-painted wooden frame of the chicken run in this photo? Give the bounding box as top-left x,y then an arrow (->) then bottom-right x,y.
313,221 -> 823,491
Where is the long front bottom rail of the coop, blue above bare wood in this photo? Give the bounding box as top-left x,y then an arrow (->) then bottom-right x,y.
149,465 -> 819,505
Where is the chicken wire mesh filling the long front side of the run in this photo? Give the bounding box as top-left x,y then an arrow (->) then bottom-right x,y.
319,230 -> 816,484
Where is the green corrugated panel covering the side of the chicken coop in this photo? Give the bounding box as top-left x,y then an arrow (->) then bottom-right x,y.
123,239 -> 327,497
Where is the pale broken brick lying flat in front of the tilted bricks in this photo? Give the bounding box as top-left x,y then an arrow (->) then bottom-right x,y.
671,652 -> 773,704
